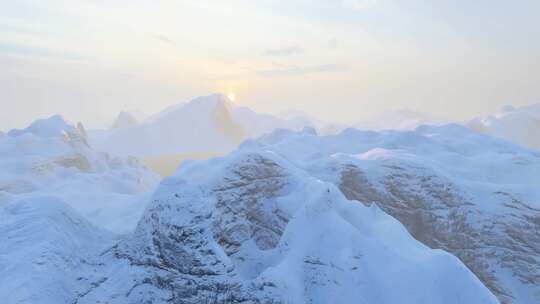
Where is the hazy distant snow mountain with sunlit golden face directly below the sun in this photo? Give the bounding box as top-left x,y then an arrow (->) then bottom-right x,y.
90,94 -> 332,157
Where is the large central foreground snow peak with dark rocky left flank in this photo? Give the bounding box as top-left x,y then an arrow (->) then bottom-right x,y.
68,148 -> 497,303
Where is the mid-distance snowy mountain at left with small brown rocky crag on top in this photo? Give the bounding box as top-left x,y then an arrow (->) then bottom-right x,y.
0,116 -> 159,232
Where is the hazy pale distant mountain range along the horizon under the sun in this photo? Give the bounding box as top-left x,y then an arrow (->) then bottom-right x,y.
89,94 -> 540,166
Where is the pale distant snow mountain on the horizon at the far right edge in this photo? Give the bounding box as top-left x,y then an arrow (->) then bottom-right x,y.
466,103 -> 540,150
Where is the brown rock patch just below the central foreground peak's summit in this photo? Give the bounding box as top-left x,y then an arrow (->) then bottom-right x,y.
212,155 -> 288,255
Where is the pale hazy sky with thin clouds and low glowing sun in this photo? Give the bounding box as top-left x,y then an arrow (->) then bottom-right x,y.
0,0 -> 540,130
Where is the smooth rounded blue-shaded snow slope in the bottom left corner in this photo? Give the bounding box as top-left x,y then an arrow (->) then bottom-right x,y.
0,196 -> 113,304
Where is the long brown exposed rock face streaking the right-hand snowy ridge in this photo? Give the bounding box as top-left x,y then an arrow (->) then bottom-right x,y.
337,159 -> 540,303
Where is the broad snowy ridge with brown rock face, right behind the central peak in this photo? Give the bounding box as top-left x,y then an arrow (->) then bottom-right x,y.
241,125 -> 540,303
